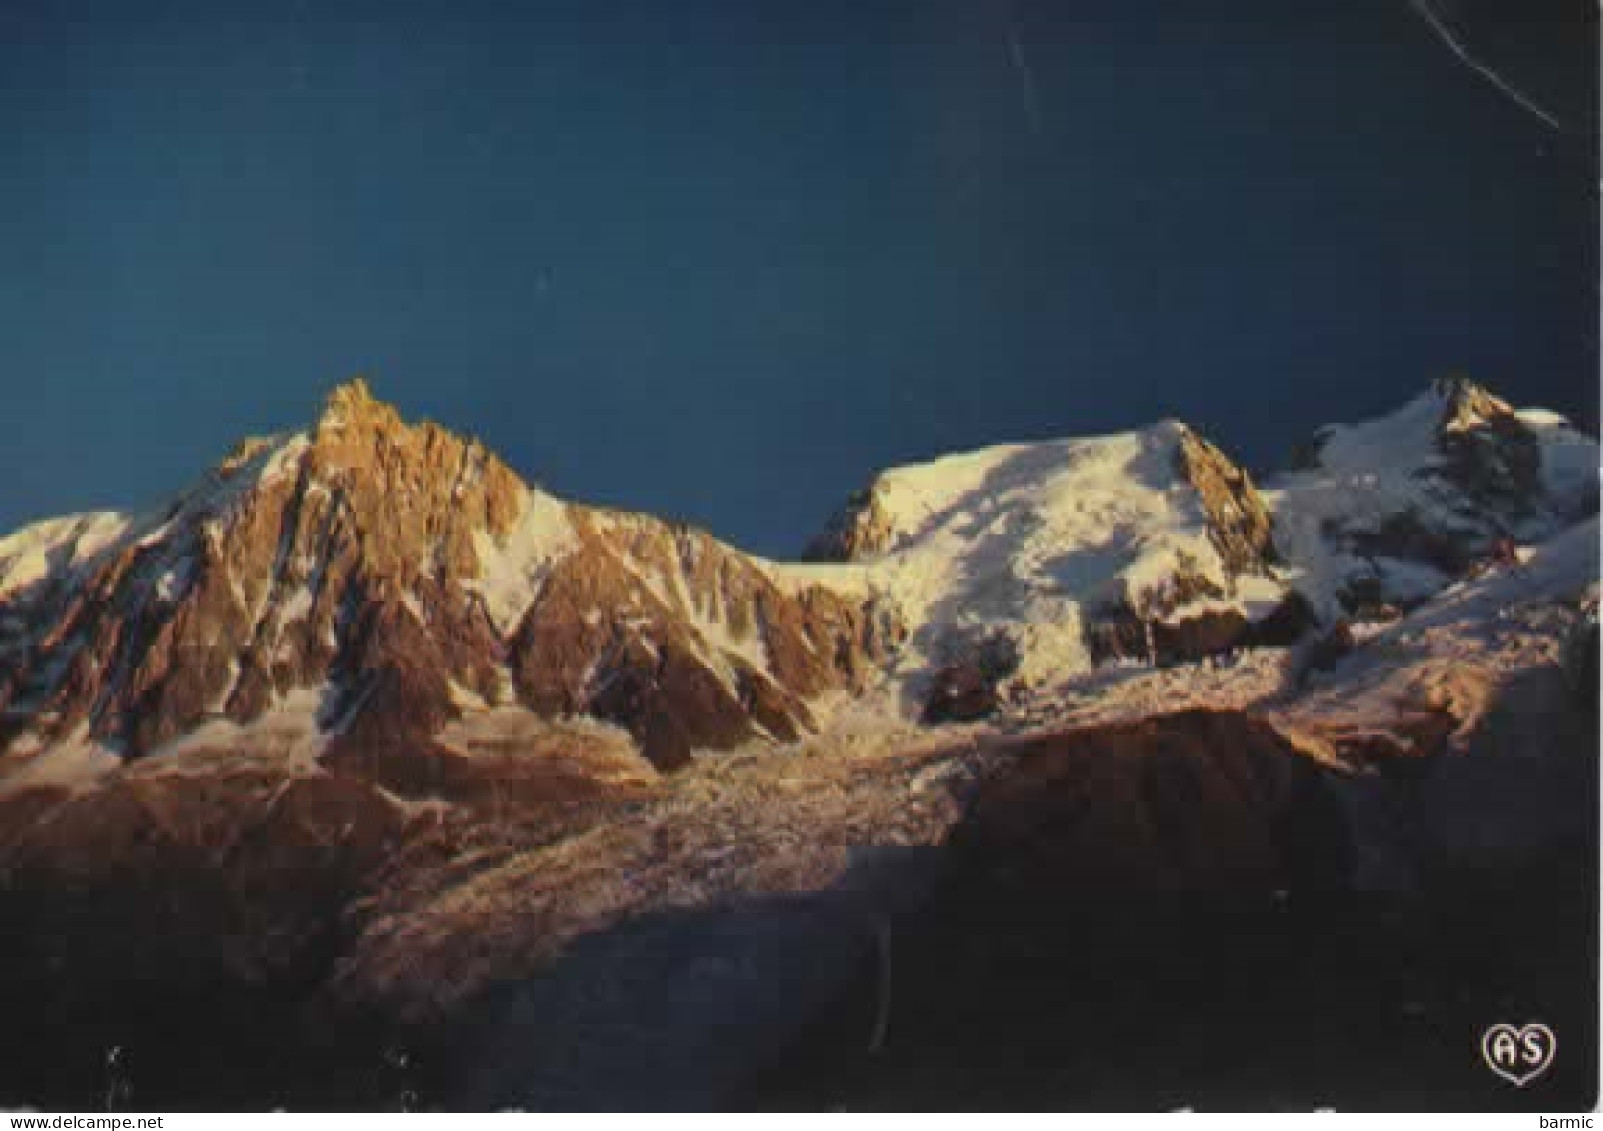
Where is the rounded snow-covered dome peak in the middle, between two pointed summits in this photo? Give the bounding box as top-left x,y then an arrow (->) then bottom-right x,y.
810,420 -> 1286,684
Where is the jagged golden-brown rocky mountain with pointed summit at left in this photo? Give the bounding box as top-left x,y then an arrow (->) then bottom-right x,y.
0,380 -> 904,764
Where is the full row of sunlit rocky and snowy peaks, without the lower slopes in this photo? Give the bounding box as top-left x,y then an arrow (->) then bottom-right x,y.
0,378 -> 1597,784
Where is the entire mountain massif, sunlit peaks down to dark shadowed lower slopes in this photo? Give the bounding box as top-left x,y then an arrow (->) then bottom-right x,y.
0,371 -> 1597,1107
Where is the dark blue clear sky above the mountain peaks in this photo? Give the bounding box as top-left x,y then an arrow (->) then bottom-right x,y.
0,0 -> 1598,554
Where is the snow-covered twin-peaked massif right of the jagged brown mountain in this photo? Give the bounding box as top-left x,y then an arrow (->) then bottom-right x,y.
808,378 -> 1597,695
